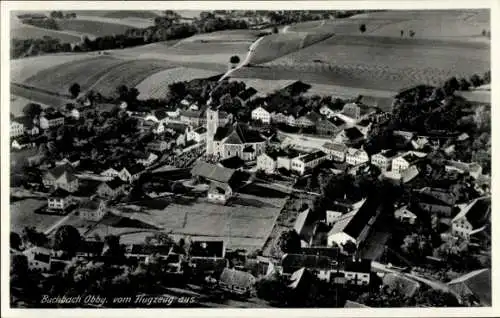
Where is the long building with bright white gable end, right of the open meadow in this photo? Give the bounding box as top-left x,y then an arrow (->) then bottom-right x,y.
328,198 -> 380,251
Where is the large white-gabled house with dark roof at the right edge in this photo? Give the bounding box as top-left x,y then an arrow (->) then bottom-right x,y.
451,197 -> 491,240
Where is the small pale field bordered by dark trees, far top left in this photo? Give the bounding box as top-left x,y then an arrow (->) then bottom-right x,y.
57,19 -> 134,36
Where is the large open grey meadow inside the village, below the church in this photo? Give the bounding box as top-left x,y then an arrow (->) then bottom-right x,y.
89,185 -> 287,250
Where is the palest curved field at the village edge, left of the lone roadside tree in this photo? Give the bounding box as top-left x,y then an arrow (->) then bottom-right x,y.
136,67 -> 219,99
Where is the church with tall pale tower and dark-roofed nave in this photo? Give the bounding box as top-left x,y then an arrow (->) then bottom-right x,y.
206,108 -> 266,161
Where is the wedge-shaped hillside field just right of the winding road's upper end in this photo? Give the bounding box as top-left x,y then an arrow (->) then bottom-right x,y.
248,32 -> 331,64
